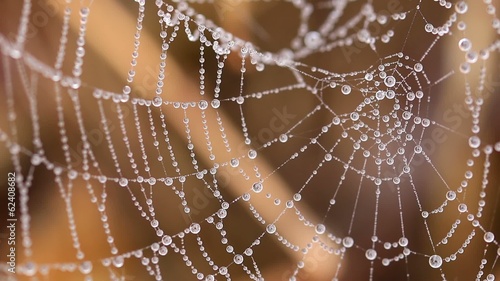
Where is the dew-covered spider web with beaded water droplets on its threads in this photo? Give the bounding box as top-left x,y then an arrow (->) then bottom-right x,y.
0,0 -> 500,280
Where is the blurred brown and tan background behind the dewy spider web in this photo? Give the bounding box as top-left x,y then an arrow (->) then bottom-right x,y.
0,0 -> 500,280
